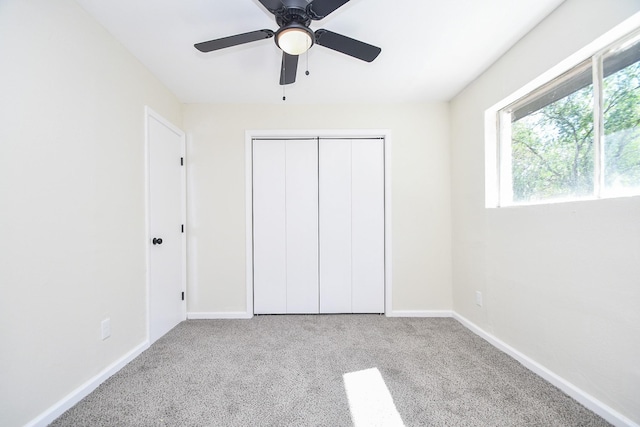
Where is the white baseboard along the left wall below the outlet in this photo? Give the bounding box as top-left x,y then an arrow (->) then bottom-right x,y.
26,341 -> 149,427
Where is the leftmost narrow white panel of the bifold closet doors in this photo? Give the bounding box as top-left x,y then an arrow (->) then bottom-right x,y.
253,141 -> 287,314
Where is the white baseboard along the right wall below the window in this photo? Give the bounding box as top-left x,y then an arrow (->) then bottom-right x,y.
453,311 -> 640,427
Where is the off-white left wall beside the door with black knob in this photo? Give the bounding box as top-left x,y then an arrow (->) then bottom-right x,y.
0,0 -> 181,426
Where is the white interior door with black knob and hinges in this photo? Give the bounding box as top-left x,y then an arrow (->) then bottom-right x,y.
147,110 -> 186,343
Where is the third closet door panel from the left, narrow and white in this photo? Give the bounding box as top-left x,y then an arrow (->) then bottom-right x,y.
319,140 -> 351,313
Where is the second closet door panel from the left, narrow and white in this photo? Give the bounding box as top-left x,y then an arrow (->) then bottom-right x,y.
286,140 -> 318,313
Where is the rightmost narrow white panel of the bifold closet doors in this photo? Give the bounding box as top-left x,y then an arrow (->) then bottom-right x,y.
351,139 -> 384,313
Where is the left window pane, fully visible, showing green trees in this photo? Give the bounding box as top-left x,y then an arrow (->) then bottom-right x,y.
510,65 -> 594,203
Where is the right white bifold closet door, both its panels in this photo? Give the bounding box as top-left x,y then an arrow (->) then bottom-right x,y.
319,139 -> 384,313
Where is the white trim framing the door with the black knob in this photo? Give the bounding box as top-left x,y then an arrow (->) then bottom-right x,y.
144,105 -> 187,345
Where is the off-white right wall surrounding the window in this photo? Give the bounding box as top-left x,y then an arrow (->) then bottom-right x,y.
451,0 -> 640,422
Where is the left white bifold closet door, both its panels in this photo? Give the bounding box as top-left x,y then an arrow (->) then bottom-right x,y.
253,140 -> 318,314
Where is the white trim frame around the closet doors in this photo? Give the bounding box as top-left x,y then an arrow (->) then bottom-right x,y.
243,129 -> 393,317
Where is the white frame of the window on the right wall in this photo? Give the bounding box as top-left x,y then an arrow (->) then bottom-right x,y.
485,14 -> 640,208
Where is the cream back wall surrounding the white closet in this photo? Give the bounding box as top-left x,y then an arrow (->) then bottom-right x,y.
183,102 -> 451,313
